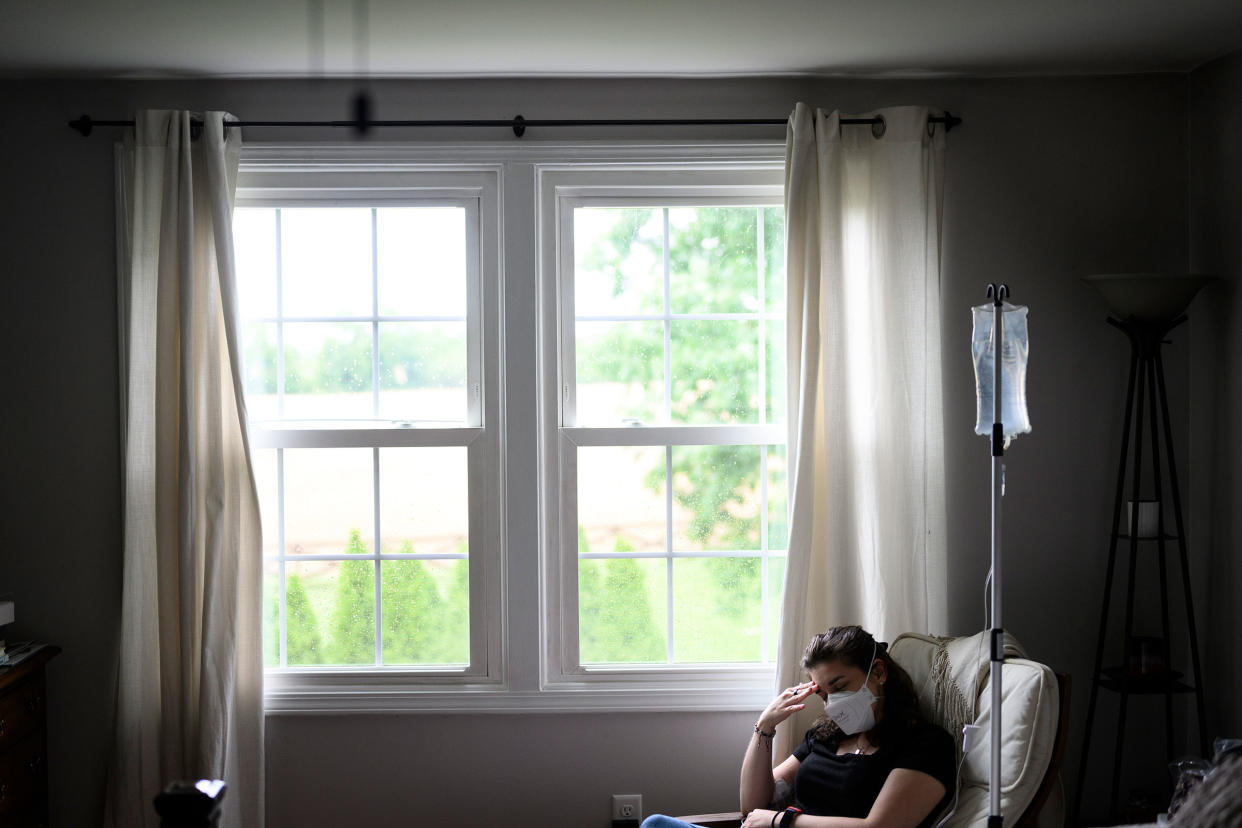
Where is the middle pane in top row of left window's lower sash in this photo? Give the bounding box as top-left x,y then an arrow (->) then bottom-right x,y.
283,448 -> 375,555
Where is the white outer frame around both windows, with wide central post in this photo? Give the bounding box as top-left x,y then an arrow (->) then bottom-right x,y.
238,140 -> 785,715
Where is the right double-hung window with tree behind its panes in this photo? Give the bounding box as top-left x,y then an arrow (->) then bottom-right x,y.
542,165 -> 786,705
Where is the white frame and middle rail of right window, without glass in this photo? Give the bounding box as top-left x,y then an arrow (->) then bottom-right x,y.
538,159 -> 787,709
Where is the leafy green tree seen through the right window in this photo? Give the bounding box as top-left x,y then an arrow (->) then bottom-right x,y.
578,207 -> 784,617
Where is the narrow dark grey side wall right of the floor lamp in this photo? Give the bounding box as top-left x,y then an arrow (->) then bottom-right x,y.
1189,52 -> 1242,737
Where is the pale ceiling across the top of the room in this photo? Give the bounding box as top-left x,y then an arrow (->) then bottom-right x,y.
0,0 -> 1242,77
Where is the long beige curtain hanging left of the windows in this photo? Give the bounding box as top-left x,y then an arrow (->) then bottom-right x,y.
106,112 -> 263,828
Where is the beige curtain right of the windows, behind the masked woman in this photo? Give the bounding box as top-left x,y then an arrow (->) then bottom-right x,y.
775,103 -> 948,761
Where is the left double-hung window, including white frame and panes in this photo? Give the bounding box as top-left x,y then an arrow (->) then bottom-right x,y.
233,157 -> 501,696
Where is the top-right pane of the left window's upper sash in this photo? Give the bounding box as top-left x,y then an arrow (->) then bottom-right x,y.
376,207 -> 466,319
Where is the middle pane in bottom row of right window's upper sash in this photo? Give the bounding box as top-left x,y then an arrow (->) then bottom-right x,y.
671,320 -> 759,425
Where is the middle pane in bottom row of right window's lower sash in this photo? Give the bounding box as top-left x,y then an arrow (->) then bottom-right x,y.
673,557 -> 761,663
